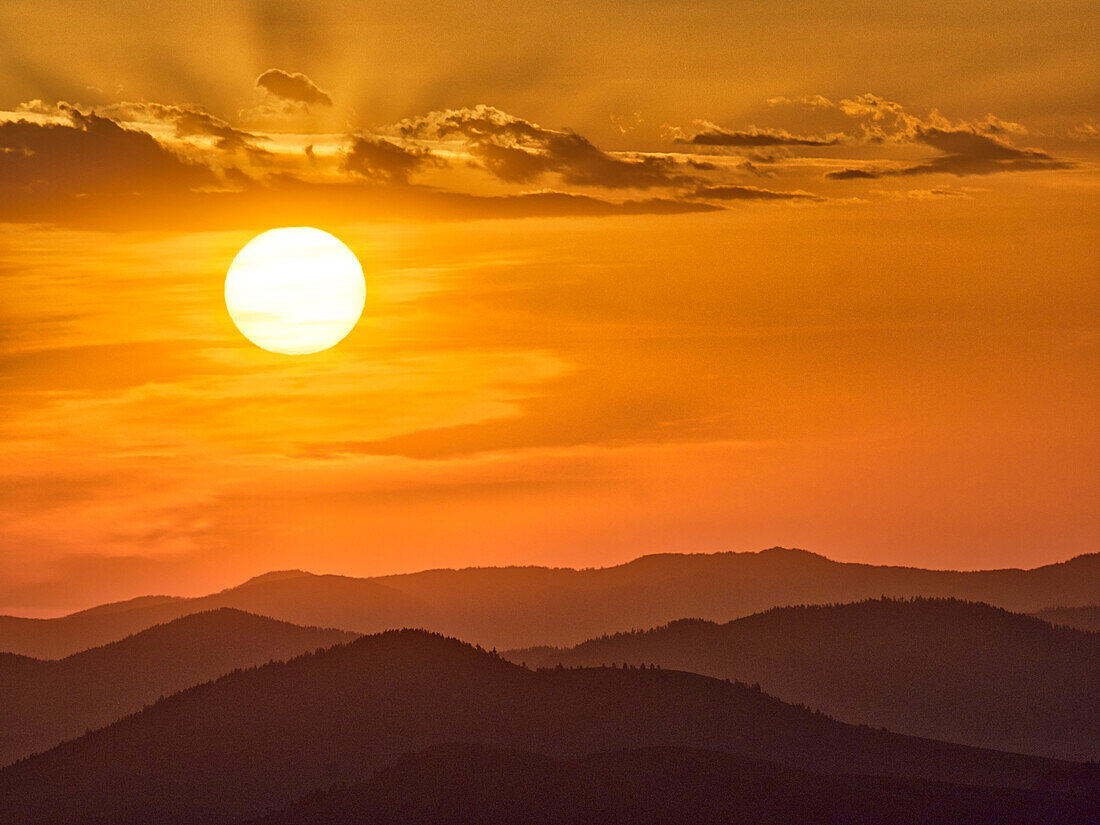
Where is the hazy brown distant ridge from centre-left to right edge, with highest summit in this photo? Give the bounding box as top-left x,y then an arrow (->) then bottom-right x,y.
375,548 -> 1100,648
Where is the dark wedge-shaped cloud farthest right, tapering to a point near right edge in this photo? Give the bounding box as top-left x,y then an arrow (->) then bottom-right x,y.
825,124 -> 1074,180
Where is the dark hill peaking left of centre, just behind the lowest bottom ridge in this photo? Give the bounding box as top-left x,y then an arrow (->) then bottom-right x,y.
0,630 -> 1100,825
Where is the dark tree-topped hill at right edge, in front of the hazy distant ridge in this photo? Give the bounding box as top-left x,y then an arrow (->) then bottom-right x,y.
505,598 -> 1100,760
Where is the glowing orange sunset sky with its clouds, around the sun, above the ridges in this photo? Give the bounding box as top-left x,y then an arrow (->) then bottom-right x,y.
0,0 -> 1100,615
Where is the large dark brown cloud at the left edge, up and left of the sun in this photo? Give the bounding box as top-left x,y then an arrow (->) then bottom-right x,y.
0,103 -> 217,199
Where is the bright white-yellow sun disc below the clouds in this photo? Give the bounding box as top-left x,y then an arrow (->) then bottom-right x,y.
226,227 -> 366,355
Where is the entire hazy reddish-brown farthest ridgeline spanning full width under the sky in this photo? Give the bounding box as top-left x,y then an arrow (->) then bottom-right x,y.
0,548 -> 1100,658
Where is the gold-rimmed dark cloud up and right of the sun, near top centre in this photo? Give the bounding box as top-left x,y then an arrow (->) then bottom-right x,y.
395,106 -> 697,189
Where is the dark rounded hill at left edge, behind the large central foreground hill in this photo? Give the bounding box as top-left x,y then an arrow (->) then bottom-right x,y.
0,608 -> 354,765
